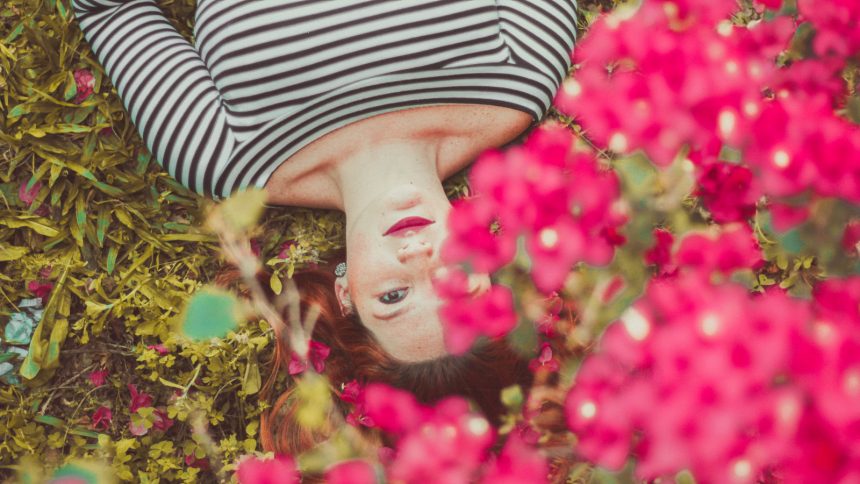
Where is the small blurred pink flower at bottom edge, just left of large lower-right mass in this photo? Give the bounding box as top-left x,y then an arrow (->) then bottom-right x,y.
481,432 -> 549,484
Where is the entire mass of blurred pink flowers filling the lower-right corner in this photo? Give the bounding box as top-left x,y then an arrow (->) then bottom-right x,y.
566,229 -> 860,482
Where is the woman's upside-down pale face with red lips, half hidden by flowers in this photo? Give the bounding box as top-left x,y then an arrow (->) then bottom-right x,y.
337,186 -> 488,361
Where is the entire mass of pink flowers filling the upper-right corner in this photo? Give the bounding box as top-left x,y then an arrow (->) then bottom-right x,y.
557,0 -> 860,223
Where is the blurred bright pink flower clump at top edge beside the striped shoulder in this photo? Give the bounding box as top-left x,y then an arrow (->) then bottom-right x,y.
557,0 -> 793,165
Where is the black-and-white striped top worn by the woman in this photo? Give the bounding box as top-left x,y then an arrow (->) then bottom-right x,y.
72,0 -> 576,198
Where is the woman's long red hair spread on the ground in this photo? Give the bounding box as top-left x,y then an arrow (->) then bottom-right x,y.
219,260 -> 532,455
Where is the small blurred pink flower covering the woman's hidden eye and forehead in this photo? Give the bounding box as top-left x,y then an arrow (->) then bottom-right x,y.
439,286 -> 517,354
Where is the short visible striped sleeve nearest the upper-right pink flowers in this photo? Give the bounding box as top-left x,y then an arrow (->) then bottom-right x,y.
496,0 -> 576,88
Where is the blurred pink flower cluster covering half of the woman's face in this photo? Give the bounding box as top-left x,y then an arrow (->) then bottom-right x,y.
444,126 -> 626,353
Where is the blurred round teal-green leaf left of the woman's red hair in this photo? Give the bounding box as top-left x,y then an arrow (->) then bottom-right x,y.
182,287 -> 238,340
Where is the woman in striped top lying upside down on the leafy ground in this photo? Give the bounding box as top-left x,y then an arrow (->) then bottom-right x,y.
73,0 -> 576,454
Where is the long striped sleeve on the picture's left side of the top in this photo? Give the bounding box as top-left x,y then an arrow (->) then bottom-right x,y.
72,0 -> 236,195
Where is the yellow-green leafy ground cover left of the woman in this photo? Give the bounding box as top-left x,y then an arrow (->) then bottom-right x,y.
0,0 -> 624,482
